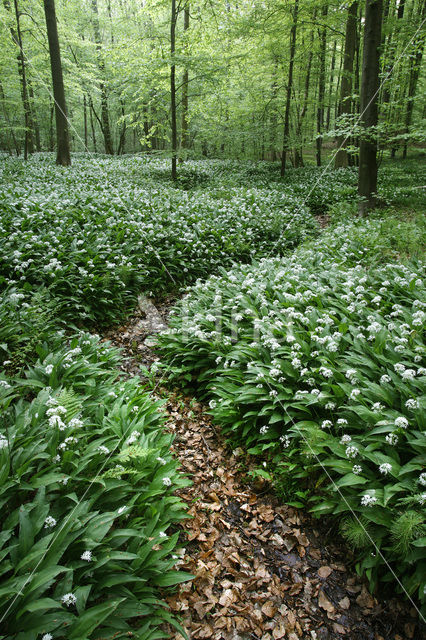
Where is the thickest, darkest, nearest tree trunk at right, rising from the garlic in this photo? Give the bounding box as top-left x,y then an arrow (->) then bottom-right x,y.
358,0 -> 383,216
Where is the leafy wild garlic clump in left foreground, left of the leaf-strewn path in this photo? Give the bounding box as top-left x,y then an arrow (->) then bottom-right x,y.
0,333 -> 189,640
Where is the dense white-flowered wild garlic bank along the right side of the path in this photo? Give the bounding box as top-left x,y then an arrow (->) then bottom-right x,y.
159,218 -> 426,602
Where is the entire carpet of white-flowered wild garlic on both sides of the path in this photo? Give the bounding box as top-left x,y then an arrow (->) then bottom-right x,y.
0,154 -> 425,639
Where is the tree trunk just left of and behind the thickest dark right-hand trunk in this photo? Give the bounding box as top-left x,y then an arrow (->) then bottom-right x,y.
334,0 -> 358,169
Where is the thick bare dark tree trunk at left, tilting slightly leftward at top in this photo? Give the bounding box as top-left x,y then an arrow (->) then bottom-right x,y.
42,0 -> 71,167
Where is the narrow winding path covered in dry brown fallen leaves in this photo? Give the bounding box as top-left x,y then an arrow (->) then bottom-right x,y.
104,297 -> 426,640
